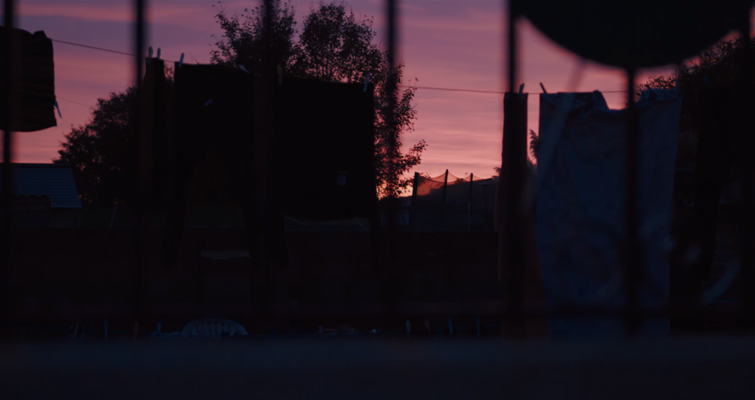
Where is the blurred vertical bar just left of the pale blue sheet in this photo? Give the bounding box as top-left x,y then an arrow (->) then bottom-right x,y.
502,0 -> 526,337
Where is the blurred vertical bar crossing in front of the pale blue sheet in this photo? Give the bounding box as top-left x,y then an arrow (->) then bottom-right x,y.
624,69 -> 643,337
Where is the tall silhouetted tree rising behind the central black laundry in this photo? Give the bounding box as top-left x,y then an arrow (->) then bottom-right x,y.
211,0 -> 427,196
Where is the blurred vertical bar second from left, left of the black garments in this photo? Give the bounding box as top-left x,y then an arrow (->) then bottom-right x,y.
132,0 -> 146,339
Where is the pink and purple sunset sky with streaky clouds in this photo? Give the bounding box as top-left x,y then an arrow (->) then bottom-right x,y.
7,0 -> 704,177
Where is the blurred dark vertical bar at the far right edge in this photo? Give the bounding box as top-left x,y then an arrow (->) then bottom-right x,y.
740,21 -> 755,328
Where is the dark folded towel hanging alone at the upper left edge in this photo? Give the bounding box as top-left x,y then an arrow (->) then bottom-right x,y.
0,27 -> 57,132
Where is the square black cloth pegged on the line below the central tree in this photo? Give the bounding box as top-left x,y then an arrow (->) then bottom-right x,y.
273,78 -> 377,223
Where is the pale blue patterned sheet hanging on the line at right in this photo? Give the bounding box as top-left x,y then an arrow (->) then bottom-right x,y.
536,90 -> 681,338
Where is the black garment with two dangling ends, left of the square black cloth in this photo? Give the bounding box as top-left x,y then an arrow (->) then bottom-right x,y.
163,64 -> 257,265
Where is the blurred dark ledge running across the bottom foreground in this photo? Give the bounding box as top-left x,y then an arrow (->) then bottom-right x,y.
0,337 -> 755,400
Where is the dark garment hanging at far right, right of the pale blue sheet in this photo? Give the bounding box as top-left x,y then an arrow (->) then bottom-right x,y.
694,86 -> 755,282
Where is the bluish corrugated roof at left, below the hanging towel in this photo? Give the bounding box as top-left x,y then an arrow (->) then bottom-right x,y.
0,164 -> 81,208
